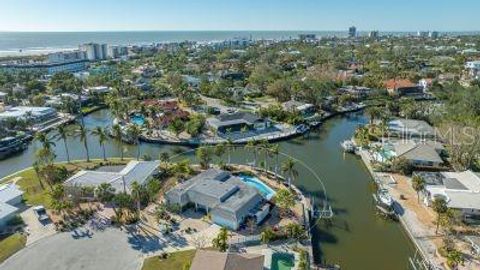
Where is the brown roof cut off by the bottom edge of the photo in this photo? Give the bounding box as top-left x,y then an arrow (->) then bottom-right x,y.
190,249 -> 265,270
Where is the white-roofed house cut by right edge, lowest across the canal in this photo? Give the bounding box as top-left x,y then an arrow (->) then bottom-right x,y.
414,171 -> 480,219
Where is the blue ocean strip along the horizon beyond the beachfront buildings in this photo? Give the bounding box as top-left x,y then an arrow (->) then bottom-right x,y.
0,31 -> 346,56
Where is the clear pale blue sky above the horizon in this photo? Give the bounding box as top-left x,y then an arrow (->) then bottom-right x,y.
0,0 -> 480,31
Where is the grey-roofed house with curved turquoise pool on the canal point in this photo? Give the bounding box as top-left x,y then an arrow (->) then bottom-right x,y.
165,169 -> 275,230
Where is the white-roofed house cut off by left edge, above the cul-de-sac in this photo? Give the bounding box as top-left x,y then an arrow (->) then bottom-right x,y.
0,184 -> 23,229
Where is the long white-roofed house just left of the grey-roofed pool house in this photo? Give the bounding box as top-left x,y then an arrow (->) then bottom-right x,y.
64,161 -> 160,193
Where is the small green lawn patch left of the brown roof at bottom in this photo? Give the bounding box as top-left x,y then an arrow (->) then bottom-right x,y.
142,250 -> 195,270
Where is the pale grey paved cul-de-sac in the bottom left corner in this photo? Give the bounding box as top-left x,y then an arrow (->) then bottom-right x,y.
0,228 -> 149,270
